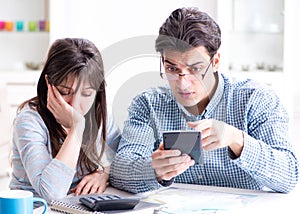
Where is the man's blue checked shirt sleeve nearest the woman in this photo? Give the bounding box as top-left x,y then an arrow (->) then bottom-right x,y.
110,93 -> 161,193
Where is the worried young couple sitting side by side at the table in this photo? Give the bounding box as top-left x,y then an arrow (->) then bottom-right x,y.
10,8 -> 298,202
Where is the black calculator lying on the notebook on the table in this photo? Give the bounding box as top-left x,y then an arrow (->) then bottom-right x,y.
79,194 -> 140,211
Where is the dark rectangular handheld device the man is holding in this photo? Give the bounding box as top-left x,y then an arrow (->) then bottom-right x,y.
162,131 -> 203,164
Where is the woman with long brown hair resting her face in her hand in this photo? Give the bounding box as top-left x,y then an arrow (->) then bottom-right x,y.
10,38 -> 120,203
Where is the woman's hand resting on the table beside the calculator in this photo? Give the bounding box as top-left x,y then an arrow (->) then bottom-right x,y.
71,170 -> 109,196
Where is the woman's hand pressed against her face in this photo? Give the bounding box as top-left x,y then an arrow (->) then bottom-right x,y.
47,84 -> 85,128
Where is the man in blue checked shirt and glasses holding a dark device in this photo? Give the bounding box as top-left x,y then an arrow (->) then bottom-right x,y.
110,8 -> 298,193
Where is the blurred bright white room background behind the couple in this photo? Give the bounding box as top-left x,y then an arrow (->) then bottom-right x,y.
0,0 -> 300,189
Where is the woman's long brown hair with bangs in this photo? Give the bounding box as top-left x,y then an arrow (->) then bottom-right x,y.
19,38 -> 107,176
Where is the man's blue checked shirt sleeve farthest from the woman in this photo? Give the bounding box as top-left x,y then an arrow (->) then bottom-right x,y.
234,90 -> 298,192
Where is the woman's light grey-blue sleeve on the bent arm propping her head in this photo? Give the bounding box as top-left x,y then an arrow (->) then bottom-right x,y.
13,111 -> 75,202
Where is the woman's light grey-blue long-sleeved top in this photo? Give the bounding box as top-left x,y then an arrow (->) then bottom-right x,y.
9,106 -> 120,203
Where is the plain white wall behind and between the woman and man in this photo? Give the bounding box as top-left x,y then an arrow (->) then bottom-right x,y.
50,0 -> 217,127
